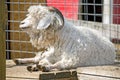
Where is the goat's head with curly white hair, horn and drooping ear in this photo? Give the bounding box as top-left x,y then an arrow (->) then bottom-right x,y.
20,5 -> 64,30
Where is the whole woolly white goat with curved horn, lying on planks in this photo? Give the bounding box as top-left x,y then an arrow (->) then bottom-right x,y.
14,5 -> 115,71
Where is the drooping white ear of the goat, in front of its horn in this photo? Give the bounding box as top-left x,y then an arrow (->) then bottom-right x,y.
37,13 -> 55,29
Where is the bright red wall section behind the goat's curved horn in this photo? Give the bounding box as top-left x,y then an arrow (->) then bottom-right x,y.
47,0 -> 79,20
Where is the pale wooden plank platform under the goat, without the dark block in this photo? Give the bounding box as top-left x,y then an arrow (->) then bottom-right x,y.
6,60 -> 120,80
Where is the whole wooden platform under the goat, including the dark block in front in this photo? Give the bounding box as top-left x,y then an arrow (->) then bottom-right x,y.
6,60 -> 120,80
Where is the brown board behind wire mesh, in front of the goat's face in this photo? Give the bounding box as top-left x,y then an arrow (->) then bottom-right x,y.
6,0 -> 45,58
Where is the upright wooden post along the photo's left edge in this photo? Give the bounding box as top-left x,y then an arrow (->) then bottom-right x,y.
0,0 -> 7,80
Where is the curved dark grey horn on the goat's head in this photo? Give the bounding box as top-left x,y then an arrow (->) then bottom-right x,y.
48,7 -> 64,28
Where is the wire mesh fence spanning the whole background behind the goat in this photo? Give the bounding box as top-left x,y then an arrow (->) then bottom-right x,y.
5,0 -> 120,59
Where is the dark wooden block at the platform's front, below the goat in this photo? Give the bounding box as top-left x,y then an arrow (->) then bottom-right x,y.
39,70 -> 78,80
